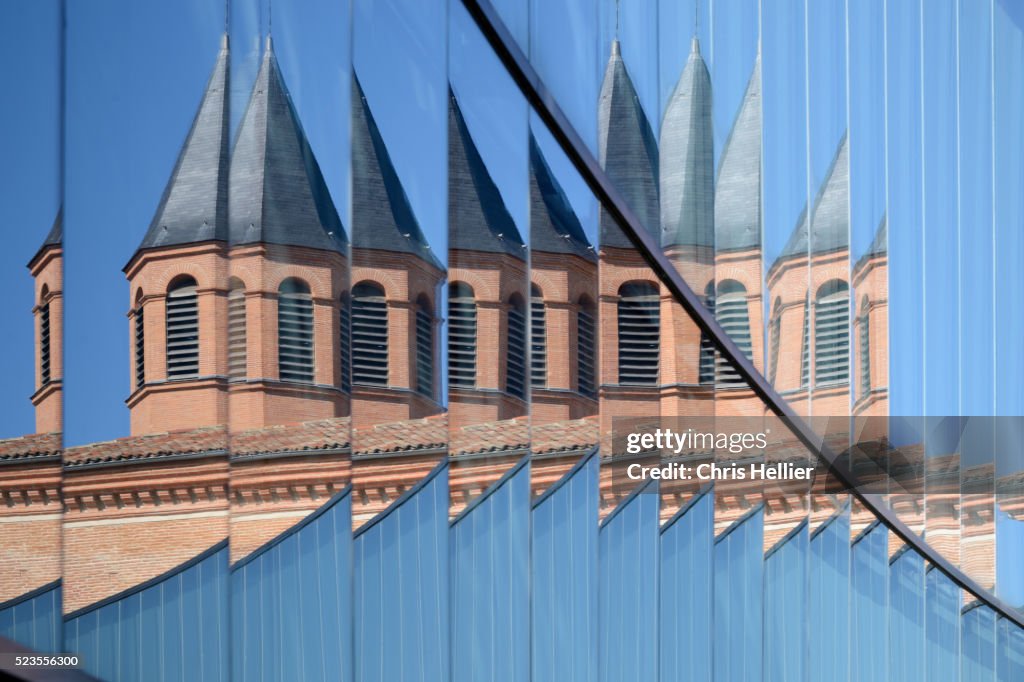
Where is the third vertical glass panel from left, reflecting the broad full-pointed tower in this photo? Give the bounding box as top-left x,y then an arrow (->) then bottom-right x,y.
219,2 -> 352,680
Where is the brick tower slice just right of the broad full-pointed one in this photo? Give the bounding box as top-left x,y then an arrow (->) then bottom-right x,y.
352,77 -> 444,427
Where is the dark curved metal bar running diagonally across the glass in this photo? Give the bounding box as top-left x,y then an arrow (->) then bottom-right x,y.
462,0 -> 1024,628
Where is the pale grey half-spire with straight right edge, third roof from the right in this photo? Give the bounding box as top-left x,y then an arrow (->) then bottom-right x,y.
715,54 -> 761,251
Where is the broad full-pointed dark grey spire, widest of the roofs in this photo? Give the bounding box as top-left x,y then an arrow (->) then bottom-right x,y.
229,38 -> 347,252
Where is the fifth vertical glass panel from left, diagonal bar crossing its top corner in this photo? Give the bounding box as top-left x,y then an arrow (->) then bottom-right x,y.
447,0 -> 528,681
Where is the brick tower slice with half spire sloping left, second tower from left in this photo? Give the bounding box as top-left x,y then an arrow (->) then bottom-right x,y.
124,37 -> 228,435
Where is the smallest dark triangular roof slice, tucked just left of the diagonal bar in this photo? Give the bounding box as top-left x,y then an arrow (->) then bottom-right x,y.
529,133 -> 597,260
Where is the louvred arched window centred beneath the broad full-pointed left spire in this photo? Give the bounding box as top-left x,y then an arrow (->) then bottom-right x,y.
278,278 -> 313,382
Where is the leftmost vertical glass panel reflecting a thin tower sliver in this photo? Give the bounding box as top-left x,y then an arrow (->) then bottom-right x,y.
0,0 -> 65,652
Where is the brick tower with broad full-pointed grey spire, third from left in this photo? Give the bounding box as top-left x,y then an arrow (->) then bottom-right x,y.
224,37 -> 349,431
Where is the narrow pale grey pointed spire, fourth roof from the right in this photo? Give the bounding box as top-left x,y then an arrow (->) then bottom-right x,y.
658,38 -> 715,247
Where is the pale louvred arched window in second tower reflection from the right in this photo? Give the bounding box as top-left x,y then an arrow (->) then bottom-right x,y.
814,280 -> 850,385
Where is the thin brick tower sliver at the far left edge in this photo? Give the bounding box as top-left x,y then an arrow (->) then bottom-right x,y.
29,210 -> 63,433
